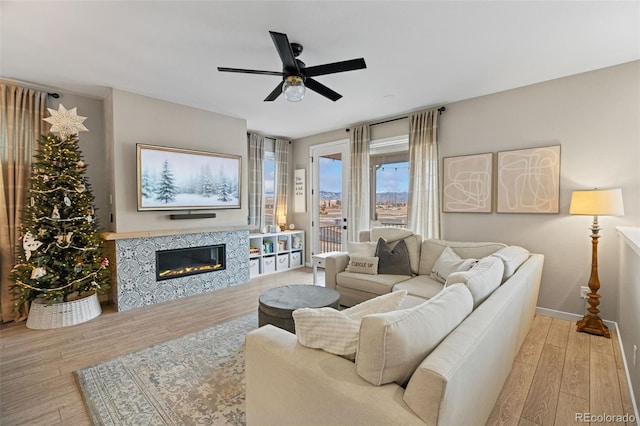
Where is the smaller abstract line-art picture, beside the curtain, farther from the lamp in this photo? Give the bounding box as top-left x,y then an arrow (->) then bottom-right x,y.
442,153 -> 493,213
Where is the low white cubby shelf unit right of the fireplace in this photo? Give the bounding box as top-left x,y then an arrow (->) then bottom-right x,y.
249,231 -> 304,277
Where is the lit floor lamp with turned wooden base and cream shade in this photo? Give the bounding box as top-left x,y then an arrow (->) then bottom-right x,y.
569,189 -> 624,338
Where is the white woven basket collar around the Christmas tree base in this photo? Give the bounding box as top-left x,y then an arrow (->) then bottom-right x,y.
27,293 -> 102,330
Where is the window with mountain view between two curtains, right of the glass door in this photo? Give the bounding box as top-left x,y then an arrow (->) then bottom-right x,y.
369,137 -> 409,228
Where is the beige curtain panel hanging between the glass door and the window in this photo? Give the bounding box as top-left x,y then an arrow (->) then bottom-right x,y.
347,124 -> 371,241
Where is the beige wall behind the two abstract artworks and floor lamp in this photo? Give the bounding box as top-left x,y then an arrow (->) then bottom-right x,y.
294,62 -> 640,320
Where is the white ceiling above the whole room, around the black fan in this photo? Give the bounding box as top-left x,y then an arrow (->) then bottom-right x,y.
0,0 -> 640,138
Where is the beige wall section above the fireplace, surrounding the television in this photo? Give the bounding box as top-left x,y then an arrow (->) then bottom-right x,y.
105,89 -> 248,232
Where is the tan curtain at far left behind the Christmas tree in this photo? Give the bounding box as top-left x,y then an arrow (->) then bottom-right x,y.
0,82 -> 49,322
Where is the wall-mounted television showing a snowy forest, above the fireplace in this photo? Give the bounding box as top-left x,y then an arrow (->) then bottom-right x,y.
136,144 -> 242,211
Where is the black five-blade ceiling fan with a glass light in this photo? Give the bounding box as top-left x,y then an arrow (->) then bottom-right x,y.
218,31 -> 367,102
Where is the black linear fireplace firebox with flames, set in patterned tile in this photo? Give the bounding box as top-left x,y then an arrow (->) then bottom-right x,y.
156,244 -> 226,281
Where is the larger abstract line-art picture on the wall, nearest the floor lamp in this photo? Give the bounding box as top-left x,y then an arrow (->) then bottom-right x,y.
497,145 -> 560,213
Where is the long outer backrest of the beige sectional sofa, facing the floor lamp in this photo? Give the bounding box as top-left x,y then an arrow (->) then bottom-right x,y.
404,254 -> 544,425
